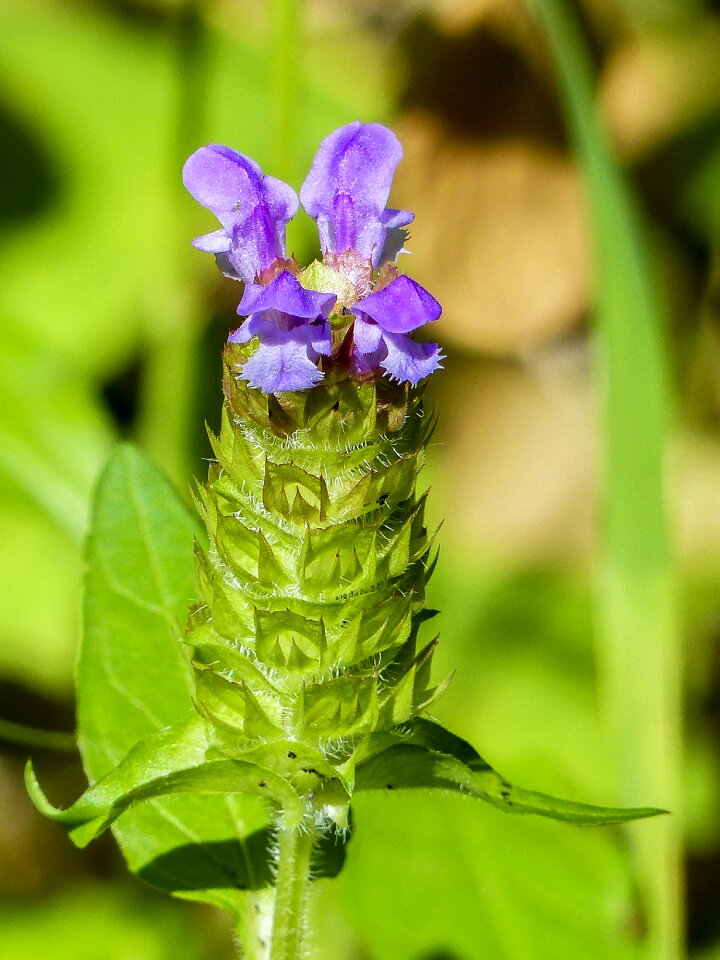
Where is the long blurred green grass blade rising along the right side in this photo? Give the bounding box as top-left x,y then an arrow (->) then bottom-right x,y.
530,0 -> 683,960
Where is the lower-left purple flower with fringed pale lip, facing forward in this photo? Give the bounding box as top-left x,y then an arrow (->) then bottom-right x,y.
228,270 -> 336,393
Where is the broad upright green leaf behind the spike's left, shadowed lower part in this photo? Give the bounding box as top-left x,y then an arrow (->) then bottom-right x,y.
78,446 -> 268,910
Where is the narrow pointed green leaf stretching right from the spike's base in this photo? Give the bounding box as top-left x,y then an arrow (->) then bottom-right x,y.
355,720 -> 666,826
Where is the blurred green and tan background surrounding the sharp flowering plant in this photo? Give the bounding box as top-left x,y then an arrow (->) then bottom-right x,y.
0,0 -> 720,960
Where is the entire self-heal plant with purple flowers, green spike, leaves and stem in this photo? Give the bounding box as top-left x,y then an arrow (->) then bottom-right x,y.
28,123 -> 657,960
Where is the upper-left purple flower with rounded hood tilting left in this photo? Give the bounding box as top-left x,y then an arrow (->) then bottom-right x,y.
183,144 -> 298,283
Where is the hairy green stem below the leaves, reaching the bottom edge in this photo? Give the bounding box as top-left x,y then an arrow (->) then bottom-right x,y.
269,824 -> 316,960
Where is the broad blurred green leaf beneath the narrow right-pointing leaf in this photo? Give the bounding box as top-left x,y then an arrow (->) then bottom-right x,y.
336,791 -> 644,960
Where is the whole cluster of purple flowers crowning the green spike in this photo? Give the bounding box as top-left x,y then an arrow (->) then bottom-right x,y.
183,121 -> 442,393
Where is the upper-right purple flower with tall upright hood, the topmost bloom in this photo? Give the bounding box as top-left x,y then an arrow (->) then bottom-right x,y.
300,120 -> 413,267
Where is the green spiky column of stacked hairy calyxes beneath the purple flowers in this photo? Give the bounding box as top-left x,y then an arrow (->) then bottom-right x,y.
185,345 -> 433,776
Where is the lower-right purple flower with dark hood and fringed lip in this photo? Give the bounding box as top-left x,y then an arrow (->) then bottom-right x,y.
352,276 -> 442,386
